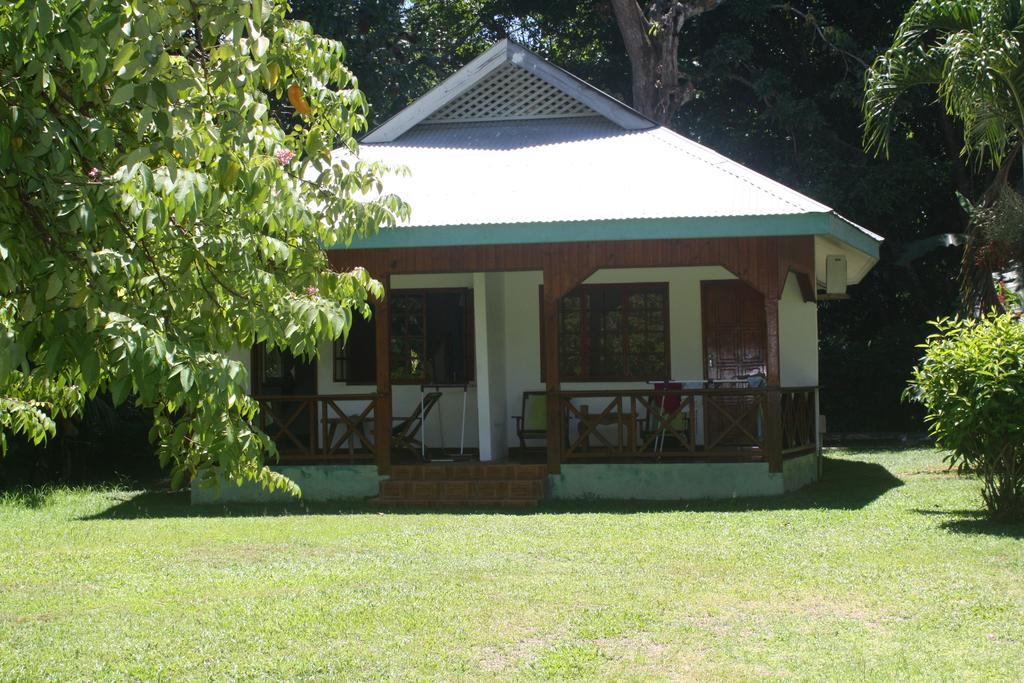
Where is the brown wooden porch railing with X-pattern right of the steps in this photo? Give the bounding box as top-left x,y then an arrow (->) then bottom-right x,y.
554,387 -> 817,461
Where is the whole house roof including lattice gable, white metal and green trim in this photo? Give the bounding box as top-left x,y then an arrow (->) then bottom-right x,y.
338,41 -> 882,282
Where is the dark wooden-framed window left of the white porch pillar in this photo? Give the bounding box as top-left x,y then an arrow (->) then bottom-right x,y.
334,289 -> 474,384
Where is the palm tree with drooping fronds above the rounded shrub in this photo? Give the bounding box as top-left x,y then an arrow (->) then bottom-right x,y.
863,0 -> 1024,312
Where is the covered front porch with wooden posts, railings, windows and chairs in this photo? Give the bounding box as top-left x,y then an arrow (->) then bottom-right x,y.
254,232 -> 818,475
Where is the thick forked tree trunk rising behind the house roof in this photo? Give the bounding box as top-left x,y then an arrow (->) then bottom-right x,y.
611,0 -> 725,126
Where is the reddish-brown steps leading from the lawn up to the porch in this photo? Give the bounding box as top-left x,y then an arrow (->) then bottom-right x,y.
376,464 -> 548,507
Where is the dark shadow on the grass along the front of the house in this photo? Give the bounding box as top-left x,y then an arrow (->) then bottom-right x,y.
84,458 -> 903,519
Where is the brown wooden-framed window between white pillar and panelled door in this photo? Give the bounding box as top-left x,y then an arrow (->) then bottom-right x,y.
541,283 -> 671,382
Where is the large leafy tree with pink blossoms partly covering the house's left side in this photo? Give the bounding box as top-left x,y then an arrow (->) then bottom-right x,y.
0,0 -> 406,493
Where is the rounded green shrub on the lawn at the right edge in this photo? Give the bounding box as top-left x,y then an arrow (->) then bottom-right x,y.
905,313 -> 1024,519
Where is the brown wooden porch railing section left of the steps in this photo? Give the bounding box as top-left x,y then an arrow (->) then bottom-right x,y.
254,394 -> 378,462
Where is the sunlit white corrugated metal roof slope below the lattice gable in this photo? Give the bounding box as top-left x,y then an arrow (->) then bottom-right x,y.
360,117 -> 847,226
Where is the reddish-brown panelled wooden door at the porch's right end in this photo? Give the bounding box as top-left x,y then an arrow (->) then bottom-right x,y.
700,280 -> 767,450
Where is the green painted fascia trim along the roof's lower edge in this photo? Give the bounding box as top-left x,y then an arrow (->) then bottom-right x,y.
338,213 -> 881,259
